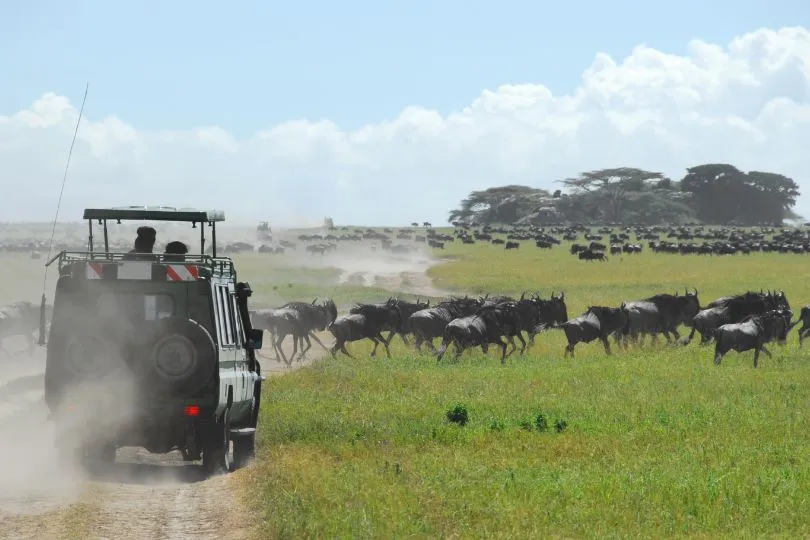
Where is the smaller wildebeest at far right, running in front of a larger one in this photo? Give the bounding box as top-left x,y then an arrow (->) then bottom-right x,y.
714,309 -> 795,367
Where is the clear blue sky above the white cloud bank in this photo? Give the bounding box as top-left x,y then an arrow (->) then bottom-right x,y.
0,0 -> 810,137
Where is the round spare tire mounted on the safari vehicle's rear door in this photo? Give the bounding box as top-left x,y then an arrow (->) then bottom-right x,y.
140,317 -> 217,395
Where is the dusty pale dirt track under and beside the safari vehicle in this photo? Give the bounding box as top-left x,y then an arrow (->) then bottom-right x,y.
0,336 -> 322,540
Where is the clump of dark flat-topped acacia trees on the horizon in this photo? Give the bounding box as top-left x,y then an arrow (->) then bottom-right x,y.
450,163 -> 799,225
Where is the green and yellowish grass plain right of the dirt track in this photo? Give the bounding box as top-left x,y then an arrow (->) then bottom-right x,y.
237,233 -> 810,538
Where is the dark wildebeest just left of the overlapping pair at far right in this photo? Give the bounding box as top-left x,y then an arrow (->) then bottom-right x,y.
617,289 -> 700,347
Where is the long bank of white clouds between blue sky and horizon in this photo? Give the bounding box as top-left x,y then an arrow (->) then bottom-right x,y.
0,27 -> 810,225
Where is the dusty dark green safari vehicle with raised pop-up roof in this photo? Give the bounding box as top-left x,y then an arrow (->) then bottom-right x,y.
45,207 -> 264,473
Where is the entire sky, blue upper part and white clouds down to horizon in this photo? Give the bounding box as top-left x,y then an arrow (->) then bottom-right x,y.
0,0 -> 810,225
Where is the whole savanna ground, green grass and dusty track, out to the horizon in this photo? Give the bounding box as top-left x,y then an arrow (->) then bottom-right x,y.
0,213 -> 810,538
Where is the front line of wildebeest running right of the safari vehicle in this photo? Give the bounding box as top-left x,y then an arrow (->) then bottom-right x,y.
251,289 -> 810,367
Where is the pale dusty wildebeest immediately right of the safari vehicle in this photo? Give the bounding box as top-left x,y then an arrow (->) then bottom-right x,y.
248,299 -> 337,366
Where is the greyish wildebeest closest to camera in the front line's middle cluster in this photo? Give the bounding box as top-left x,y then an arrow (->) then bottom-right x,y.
436,302 -> 518,364
